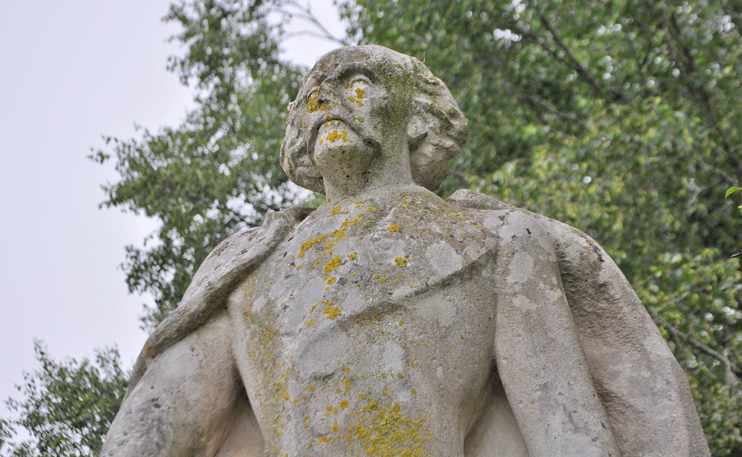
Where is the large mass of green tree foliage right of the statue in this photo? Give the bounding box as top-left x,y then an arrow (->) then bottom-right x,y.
342,0 -> 742,450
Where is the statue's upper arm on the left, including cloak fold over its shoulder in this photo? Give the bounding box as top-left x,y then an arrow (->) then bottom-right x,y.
101,207 -> 312,457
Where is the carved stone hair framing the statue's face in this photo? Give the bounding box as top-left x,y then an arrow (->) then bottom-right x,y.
281,45 -> 469,193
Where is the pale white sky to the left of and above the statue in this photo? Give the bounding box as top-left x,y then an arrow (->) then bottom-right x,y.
0,0 -> 343,417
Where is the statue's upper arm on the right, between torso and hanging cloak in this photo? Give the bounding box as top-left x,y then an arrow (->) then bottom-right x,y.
495,211 -> 620,457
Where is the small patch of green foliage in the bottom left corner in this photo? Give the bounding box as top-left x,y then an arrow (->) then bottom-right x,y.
0,341 -> 129,457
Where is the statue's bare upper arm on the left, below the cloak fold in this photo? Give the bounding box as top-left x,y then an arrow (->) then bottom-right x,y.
101,312 -> 263,457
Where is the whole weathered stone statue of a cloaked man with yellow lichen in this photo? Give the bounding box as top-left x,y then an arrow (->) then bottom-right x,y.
102,46 -> 710,457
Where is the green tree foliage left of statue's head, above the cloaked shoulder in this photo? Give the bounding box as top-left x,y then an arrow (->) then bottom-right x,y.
91,0 -> 301,329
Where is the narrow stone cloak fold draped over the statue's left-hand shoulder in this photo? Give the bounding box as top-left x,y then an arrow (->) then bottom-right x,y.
129,206 -> 314,391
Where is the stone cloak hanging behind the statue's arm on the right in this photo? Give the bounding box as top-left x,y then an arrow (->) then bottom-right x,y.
532,214 -> 711,457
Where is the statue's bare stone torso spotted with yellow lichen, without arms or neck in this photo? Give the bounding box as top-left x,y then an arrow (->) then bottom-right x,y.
229,188 -> 506,456
